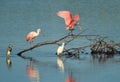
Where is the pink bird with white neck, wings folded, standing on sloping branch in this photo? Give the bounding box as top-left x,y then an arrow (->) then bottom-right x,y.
26,29 -> 42,44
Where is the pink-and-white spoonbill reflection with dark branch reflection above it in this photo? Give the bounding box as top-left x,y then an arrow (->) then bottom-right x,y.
17,56 -> 40,82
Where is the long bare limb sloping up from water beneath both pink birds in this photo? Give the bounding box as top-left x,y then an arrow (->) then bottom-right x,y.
17,29 -> 98,55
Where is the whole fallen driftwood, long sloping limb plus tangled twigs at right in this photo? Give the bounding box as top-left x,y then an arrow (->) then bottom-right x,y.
17,29 -> 120,57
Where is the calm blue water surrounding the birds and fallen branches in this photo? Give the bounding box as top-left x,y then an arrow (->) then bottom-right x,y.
0,0 -> 120,82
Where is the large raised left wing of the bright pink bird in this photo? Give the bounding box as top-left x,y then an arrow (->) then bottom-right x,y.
57,11 -> 72,25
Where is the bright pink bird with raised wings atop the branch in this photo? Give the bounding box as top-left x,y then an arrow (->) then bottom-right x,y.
57,11 -> 81,31
